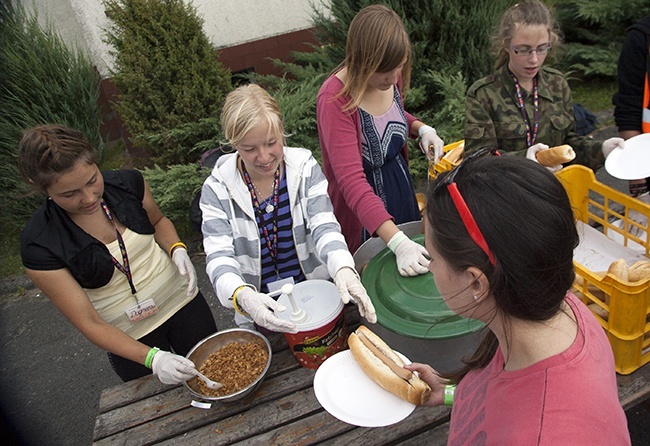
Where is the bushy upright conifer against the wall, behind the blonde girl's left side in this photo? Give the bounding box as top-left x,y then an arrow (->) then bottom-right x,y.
104,0 -> 231,166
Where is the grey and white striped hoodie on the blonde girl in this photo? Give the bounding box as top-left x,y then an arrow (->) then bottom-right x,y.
201,147 -> 354,325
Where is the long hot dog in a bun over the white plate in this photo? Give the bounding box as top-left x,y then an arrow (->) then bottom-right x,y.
348,325 -> 431,406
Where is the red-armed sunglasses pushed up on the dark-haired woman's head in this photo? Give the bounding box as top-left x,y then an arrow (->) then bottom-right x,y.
433,147 -> 500,266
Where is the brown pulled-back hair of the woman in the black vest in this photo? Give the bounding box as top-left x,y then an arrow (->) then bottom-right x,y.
18,124 -> 99,193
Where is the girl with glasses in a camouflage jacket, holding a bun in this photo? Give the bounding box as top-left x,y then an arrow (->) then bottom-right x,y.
464,0 -> 624,171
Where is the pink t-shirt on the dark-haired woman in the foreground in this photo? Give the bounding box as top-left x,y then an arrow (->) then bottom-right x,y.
448,293 -> 630,446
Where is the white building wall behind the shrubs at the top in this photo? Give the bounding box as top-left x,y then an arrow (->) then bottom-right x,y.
25,0 -> 329,78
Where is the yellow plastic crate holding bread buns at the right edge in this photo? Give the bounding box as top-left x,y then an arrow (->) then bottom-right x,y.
556,165 -> 650,375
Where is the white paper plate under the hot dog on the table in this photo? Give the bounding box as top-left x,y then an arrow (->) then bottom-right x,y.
314,350 -> 415,427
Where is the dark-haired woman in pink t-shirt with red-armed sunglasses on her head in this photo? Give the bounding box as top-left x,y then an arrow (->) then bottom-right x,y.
406,153 -> 630,445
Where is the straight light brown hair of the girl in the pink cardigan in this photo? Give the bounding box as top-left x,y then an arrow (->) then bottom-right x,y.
340,5 -> 412,110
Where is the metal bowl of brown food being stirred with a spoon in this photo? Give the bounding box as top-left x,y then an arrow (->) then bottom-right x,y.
183,328 -> 271,402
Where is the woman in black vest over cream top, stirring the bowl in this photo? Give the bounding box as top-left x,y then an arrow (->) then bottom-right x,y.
18,125 -> 217,384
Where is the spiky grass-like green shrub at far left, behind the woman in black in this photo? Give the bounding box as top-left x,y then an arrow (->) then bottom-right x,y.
0,2 -> 104,245
